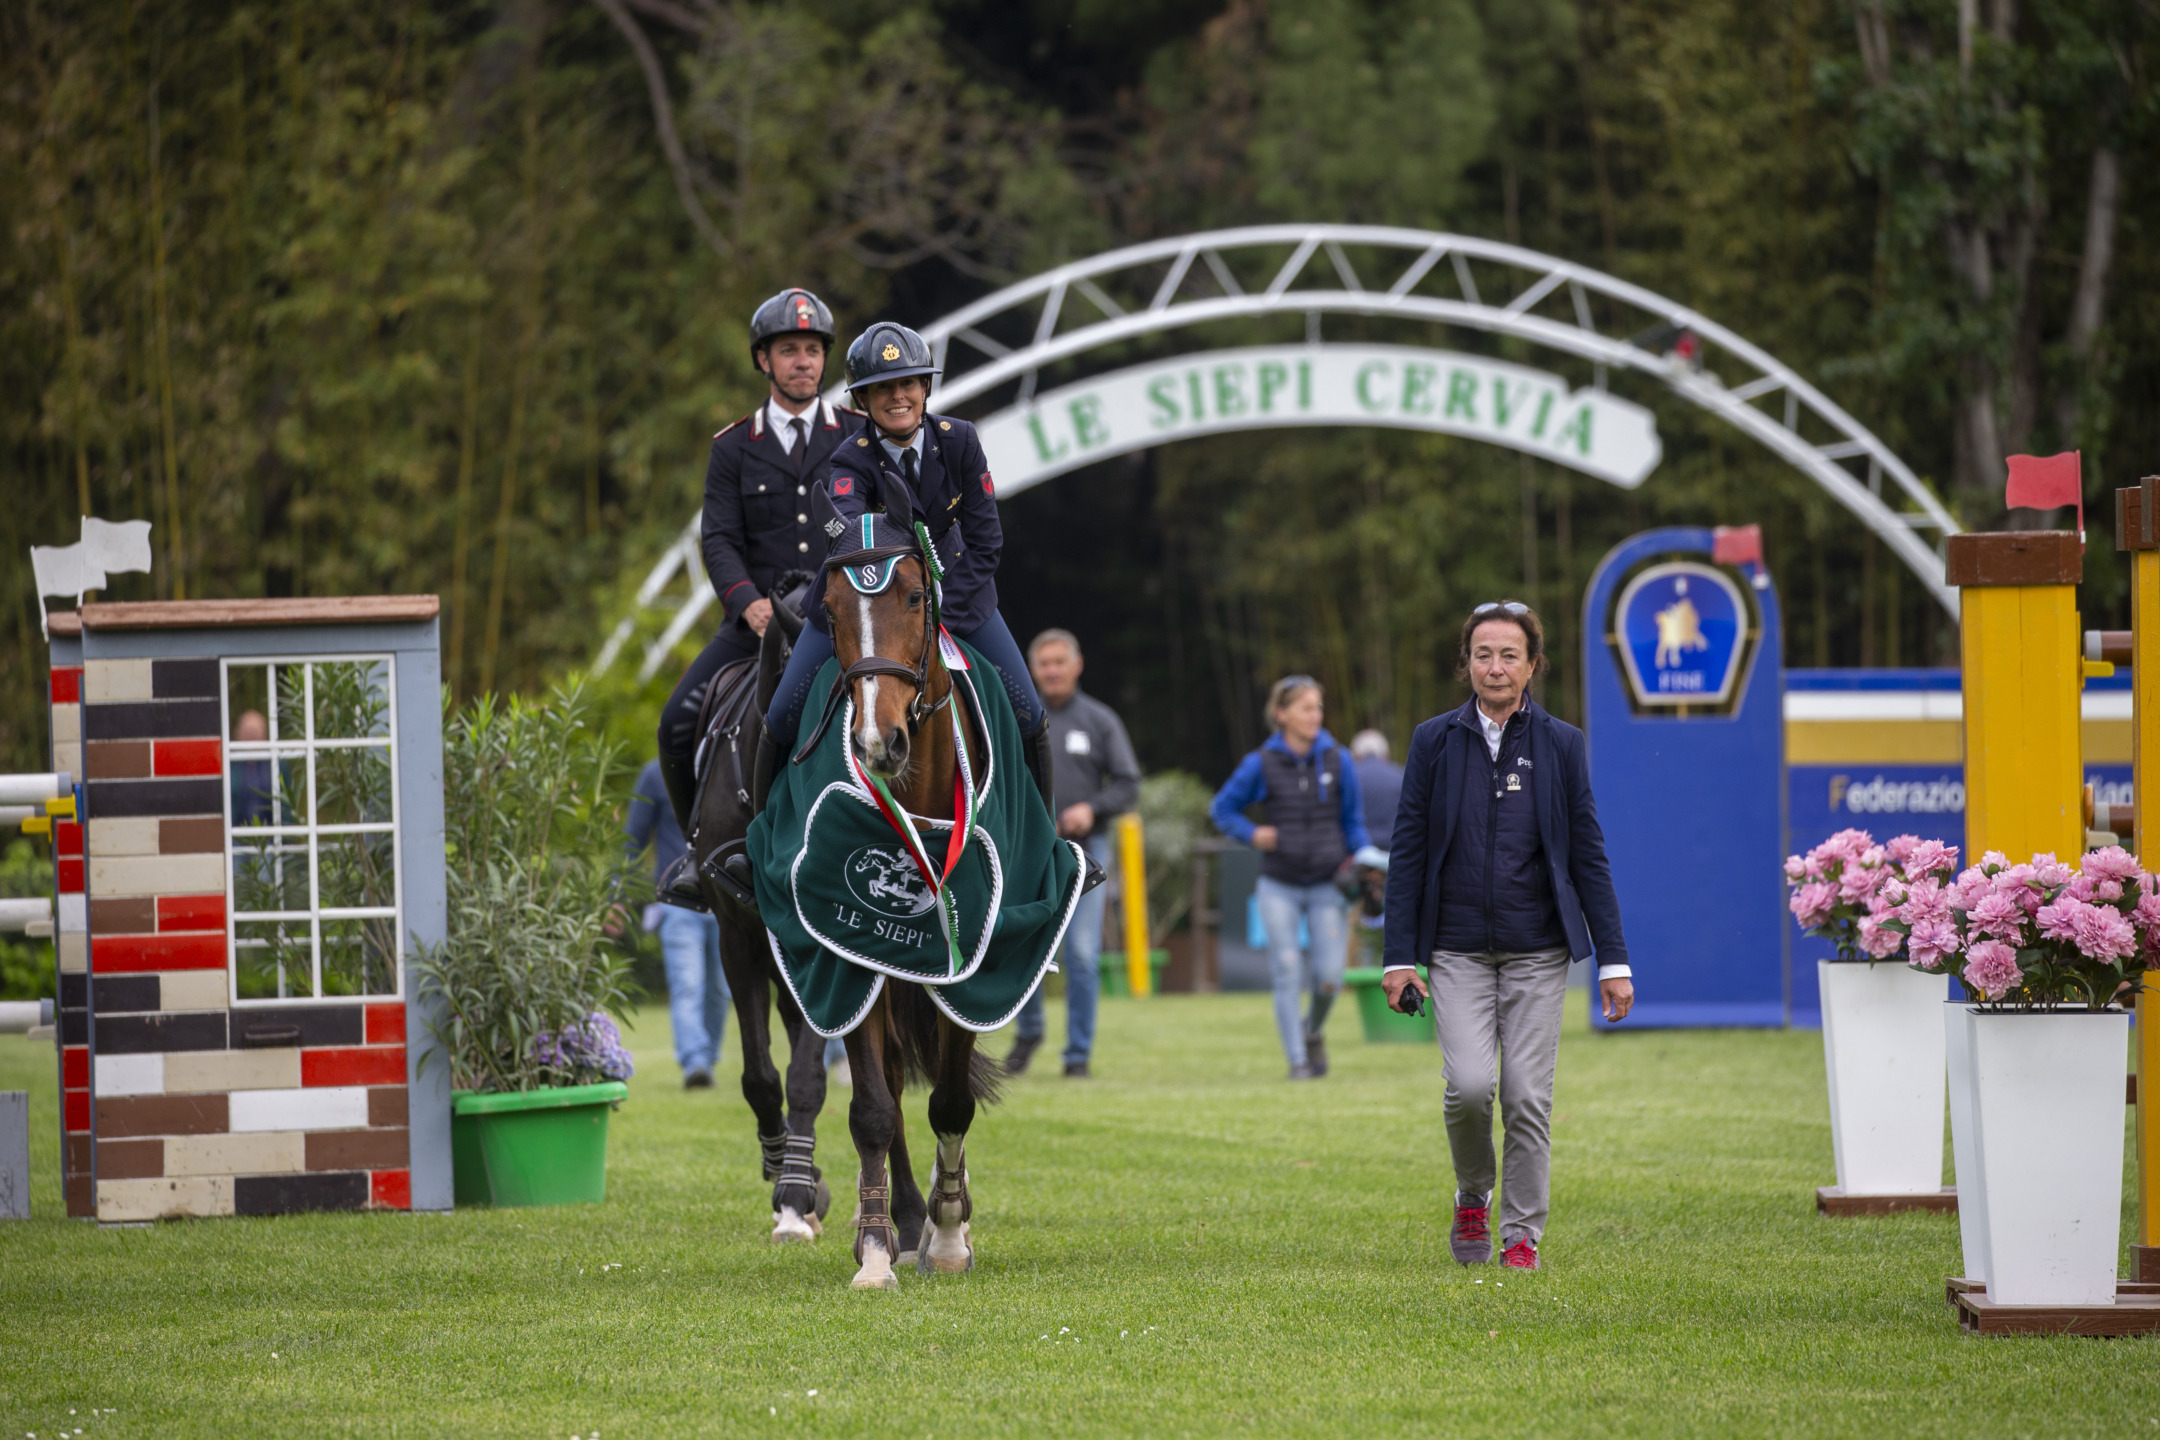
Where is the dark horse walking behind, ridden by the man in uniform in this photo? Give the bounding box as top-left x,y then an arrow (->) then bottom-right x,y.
689,572 -> 832,1241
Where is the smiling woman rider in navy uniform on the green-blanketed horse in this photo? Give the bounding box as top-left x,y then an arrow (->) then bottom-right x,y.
758,322 -> 1050,805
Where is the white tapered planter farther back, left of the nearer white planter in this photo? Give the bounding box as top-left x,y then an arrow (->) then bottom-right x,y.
1814,961 -> 1946,1196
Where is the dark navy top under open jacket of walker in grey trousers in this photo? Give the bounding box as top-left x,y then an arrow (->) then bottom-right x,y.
1434,710 -> 1568,954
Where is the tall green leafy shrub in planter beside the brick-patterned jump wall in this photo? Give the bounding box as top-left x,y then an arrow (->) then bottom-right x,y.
413,680 -> 631,1090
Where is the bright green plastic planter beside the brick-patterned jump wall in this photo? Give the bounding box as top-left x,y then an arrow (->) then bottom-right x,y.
449,1079 -> 631,1205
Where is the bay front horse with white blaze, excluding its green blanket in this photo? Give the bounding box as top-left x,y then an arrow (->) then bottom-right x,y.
812,524 -> 1002,1289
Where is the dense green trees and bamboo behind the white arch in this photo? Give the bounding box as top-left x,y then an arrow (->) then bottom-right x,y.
0,0 -> 2160,790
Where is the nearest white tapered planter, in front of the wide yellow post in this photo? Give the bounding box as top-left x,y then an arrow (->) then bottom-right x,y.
1957,1010 -> 2130,1304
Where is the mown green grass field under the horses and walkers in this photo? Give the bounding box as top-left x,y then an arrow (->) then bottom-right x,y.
0,995 -> 2160,1440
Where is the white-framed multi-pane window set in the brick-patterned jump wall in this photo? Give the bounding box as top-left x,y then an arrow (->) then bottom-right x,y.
218,652 -> 404,1008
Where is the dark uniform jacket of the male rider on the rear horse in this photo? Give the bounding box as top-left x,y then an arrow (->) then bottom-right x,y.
702,399 -> 862,624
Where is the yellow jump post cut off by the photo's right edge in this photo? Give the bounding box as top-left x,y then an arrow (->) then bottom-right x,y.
2115,477 -> 2160,1280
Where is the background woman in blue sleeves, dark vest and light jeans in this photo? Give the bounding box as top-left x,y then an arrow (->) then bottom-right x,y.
1207,676 -> 1372,1079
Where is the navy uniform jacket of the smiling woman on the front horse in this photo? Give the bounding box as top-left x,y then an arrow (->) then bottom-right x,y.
814,405 -> 1004,635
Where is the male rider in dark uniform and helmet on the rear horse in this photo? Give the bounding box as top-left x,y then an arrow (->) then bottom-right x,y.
659,289 -> 862,909
